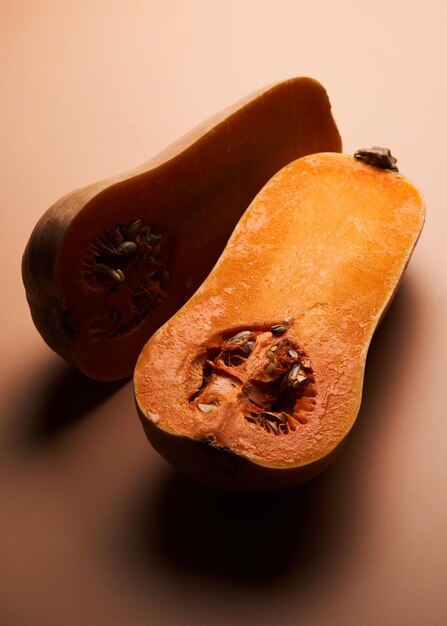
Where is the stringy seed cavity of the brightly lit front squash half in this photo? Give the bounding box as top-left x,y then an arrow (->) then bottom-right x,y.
190,324 -> 316,436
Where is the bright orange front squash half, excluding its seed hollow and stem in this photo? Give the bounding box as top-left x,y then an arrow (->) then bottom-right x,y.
134,153 -> 425,491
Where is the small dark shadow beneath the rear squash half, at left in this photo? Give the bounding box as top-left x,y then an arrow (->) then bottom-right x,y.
11,360 -> 128,446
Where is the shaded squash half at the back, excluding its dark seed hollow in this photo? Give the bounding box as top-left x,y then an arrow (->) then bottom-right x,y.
22,78 -> 341,381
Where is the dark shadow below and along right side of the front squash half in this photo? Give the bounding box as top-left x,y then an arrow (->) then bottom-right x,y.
121,281 -> 417,593
